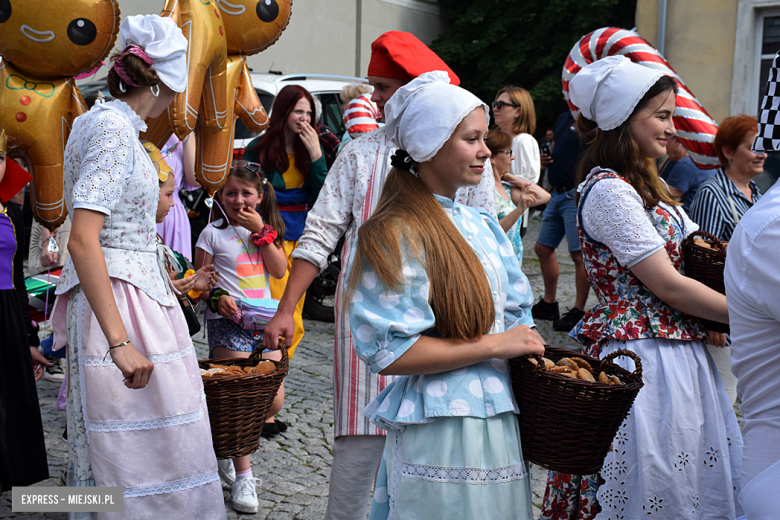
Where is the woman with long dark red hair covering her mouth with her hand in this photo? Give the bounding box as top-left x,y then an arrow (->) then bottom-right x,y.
244,85 -> 328,366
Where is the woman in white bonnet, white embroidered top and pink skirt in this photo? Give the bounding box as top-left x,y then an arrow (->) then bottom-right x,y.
53,15 -> 225,519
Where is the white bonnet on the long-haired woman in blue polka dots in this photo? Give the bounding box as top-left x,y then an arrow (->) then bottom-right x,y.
385,70 -> 489,163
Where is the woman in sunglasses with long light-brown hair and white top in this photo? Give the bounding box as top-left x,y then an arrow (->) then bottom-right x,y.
493,86 -> 542,187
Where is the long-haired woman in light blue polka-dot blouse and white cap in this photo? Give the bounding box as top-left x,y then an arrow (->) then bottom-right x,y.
345,72 -> 544,519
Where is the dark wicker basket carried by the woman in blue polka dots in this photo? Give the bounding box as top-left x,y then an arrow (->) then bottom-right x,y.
509,346 -> 643,475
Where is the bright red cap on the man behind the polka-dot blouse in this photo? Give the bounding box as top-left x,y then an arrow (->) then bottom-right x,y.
368,31 -> 460,85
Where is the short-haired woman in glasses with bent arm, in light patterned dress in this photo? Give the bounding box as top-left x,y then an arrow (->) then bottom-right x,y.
485,128 -> 550,267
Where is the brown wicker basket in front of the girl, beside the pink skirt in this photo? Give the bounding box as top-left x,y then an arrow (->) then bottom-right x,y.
198,344 -> 289,459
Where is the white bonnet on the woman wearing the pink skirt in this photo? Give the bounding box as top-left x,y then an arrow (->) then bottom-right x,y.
119,14 -> 188,92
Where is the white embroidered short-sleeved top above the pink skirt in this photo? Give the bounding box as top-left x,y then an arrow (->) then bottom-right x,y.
57,100 -> 176,306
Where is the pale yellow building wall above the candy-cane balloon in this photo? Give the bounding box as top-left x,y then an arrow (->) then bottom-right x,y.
636,0 -> 738,122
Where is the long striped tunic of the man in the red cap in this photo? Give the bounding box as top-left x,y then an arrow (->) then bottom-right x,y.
292,128 -> 496,437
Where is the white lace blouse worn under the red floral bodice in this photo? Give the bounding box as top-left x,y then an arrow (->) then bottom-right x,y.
578,169 -> 699,268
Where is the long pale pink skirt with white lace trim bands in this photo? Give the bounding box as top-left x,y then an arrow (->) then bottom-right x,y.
52,278 -> 225,519
